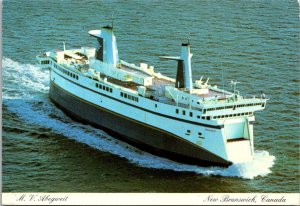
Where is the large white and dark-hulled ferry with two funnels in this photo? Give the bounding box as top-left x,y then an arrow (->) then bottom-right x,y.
37,26 -> 267,167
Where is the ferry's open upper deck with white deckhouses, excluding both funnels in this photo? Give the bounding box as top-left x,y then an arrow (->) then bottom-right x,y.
40,48 -> 266,116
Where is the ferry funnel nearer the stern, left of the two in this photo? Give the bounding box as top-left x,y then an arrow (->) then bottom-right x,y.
89,26 -> 119,65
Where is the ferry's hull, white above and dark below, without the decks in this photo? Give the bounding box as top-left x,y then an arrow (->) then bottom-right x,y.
50,62 -> 252,166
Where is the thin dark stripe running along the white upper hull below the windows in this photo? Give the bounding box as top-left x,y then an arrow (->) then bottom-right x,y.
51,68 -> 224,129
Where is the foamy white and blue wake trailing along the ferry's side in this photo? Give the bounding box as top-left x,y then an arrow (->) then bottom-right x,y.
2,57 -> 275,179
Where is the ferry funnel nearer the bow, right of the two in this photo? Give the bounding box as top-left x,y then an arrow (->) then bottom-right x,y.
160,43 -> 193,90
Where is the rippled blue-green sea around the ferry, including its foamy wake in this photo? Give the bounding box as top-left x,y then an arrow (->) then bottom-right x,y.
2,0 -> 300,193
